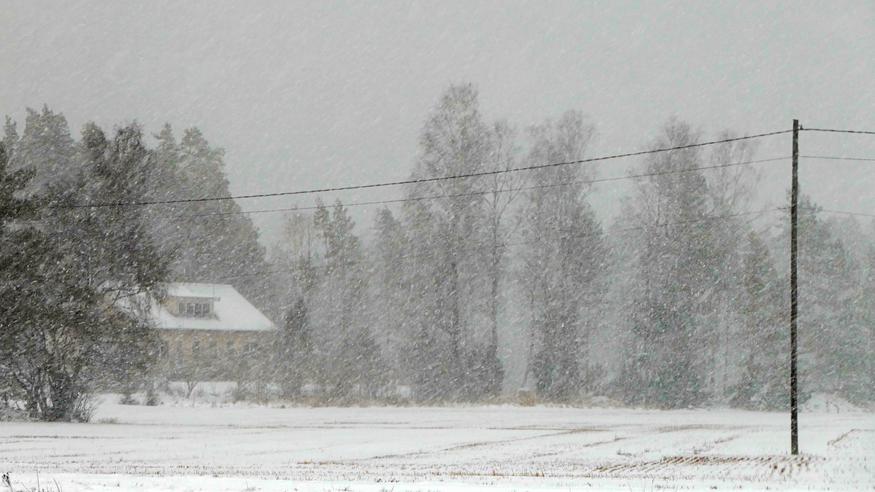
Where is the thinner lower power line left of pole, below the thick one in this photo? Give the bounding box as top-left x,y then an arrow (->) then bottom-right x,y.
175,156 -> 790,218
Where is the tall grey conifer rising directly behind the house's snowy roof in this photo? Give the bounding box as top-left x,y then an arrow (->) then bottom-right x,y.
147,125 -> 279,316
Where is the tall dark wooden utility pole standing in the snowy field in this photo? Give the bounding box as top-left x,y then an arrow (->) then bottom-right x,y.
790,120 -> 799,455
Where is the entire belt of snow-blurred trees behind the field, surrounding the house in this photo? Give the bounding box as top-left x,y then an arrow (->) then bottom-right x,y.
0,84 -> 875,420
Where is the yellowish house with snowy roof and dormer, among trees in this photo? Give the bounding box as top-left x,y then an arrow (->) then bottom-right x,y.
150,282 -> 277,379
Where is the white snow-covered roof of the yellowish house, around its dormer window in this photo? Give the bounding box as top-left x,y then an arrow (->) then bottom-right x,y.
151,282 -> 276,331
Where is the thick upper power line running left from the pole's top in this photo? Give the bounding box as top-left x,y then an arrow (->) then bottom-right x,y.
48,130 -> 792,209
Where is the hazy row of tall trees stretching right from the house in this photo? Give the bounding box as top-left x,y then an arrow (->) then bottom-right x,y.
271,84 -> 875,410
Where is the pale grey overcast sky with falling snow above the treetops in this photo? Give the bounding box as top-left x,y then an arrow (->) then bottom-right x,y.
0,0 -> 875,246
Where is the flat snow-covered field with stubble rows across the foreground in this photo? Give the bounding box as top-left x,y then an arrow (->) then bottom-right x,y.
0,402 -> 875,492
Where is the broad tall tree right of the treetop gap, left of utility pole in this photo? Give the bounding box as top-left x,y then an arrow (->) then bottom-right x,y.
622,120 -> 717,407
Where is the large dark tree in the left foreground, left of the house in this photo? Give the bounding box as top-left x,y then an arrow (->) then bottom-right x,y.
0,114 -> 165,420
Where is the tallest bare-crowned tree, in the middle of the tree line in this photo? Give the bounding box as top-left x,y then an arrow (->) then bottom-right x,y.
405,84 -> 491,400
